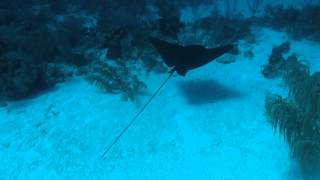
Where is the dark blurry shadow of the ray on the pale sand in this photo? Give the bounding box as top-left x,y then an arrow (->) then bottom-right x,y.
178,80 -> 244,105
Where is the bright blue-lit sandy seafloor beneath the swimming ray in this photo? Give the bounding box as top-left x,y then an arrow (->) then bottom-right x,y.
0,29 -> 320,180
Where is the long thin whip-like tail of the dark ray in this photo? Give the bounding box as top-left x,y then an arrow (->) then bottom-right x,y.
101,69 -> 175,159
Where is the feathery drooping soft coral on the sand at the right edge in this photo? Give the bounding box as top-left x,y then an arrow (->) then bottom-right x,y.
265,57 -> 320,179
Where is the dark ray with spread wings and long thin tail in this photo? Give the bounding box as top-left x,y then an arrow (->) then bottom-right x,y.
102,37 -> 236,159
